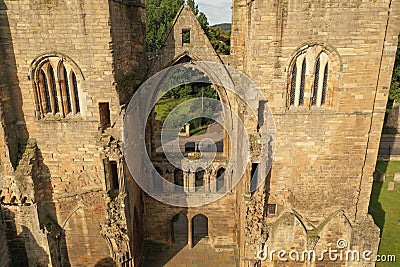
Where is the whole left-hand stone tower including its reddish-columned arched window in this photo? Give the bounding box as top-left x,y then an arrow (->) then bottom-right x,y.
0,0 -> 147,266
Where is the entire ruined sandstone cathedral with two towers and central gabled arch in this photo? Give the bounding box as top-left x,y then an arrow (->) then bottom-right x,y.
0,0 -> 400,267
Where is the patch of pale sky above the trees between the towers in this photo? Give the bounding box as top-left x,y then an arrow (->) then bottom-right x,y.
195,0 -> 232,25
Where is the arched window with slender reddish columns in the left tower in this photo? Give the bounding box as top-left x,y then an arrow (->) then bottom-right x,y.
32,57 -> 82,118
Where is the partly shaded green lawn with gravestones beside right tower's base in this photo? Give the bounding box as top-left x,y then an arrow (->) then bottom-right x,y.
370,161 -> 400,267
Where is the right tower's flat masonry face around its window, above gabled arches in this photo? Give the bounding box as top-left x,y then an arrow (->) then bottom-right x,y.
232,1 -> 399,264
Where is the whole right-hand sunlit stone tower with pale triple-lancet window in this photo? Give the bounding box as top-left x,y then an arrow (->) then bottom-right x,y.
231,0 -> 400,266
